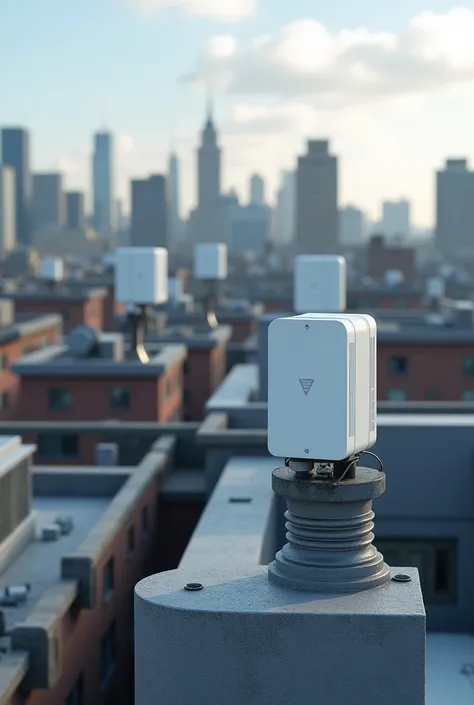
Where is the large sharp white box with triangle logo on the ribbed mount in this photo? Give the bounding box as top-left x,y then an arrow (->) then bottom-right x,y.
268,313 -> 377,461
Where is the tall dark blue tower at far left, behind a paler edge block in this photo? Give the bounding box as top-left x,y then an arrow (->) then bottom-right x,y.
2,127 -> 32,245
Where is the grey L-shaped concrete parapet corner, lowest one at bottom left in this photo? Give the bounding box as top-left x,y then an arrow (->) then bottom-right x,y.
11,582 -> 77,690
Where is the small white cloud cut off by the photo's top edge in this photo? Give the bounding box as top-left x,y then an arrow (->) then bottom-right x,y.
126,0 -> 257,22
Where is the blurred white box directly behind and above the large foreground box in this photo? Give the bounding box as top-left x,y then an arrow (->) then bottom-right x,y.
294,255 -> 347,313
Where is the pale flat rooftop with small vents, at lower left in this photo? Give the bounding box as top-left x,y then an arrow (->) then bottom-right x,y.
0,497 -> 111,629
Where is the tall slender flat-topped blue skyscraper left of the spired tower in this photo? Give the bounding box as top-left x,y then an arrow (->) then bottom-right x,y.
92,132 -> 115,238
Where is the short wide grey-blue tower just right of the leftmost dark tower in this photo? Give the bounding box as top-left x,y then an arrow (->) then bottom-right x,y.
31,173 -> 65,233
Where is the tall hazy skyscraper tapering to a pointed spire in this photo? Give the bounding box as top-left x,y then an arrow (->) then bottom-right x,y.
195,100 -> 222,242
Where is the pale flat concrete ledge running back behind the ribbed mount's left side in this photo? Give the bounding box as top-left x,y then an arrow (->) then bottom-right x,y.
180,457 -> 278,568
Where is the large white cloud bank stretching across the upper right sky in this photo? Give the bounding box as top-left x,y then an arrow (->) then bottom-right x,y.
188,8 -> 474,107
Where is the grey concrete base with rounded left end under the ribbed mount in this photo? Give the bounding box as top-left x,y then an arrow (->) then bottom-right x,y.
135,566 -> 425,705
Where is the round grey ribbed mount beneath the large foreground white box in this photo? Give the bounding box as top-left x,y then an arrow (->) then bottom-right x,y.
268,467 -> 390,593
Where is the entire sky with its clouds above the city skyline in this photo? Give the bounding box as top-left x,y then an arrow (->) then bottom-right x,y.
0,0 -> 474,226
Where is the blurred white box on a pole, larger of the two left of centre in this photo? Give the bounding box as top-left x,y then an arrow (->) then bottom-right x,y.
115,247 -> 168,305
